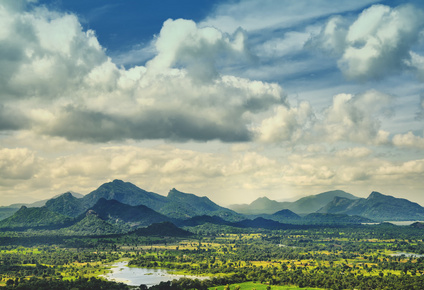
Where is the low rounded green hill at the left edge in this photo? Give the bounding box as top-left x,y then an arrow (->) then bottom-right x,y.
0,206 -> 73,230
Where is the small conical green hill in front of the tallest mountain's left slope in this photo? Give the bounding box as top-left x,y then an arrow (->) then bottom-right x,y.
59,211 -> 121,236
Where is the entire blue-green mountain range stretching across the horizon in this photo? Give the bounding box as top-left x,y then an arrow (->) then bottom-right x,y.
0,180 -> 424,234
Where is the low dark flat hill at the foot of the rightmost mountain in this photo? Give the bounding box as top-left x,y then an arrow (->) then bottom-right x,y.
302,213 -> 374,224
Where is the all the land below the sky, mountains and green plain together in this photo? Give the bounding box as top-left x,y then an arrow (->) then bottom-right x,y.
0,180 -> 424,289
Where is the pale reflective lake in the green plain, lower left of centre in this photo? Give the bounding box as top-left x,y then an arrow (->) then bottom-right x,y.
103,261 -> 209,287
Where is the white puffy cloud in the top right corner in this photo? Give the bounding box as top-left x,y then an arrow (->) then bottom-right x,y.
309,5 -> 424,80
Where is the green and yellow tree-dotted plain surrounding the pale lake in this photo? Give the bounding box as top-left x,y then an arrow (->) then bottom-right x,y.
0,223 -> 424,289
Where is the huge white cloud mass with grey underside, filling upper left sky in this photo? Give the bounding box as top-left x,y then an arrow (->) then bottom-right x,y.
0,2 -> 286,142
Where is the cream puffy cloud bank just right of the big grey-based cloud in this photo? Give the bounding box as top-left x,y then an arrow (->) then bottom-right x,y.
255,90 -> 393,144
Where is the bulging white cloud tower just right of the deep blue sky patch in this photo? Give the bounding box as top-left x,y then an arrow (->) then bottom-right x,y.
146,19 -> 248,82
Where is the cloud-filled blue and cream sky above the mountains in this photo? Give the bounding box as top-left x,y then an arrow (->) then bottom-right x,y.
0,0 -> 424,205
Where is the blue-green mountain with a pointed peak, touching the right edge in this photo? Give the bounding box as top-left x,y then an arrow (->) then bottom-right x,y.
318,191 -> 424,221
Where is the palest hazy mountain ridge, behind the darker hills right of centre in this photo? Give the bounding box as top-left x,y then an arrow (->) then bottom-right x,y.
230,190 -> 358,215
